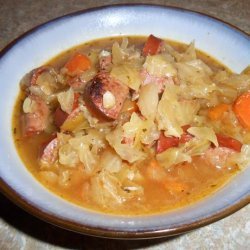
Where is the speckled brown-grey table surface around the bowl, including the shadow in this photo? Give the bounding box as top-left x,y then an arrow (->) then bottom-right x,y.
0,0 -> 250,250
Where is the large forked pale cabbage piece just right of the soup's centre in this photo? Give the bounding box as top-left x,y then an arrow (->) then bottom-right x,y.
156,85 -> 200,137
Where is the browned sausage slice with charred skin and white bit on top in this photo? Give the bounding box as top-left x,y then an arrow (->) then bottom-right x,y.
84,73 -> 129,120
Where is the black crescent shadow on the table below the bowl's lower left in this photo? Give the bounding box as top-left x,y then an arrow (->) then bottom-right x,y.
0,191 -> 180,250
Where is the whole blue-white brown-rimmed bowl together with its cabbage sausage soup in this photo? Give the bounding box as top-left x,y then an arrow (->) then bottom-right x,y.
0,5 -> 250,238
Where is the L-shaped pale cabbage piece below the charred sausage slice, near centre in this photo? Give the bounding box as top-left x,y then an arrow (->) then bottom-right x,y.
106,128 -> 146,163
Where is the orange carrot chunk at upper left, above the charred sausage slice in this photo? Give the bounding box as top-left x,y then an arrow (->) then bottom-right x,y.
64,53 -> 91,75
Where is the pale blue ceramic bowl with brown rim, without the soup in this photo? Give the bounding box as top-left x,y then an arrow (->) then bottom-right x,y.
0,5 -> 250,239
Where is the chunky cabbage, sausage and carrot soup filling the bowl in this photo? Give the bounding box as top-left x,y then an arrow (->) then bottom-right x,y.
13,35 -> 250,215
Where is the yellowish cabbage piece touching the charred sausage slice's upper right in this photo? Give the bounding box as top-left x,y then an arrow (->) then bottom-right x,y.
110,63 -> 142,91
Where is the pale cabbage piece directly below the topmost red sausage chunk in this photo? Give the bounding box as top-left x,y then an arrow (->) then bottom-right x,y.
143,54 -> 177,77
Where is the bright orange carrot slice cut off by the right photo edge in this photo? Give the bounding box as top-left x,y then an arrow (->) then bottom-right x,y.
233,91 -> 250,129
